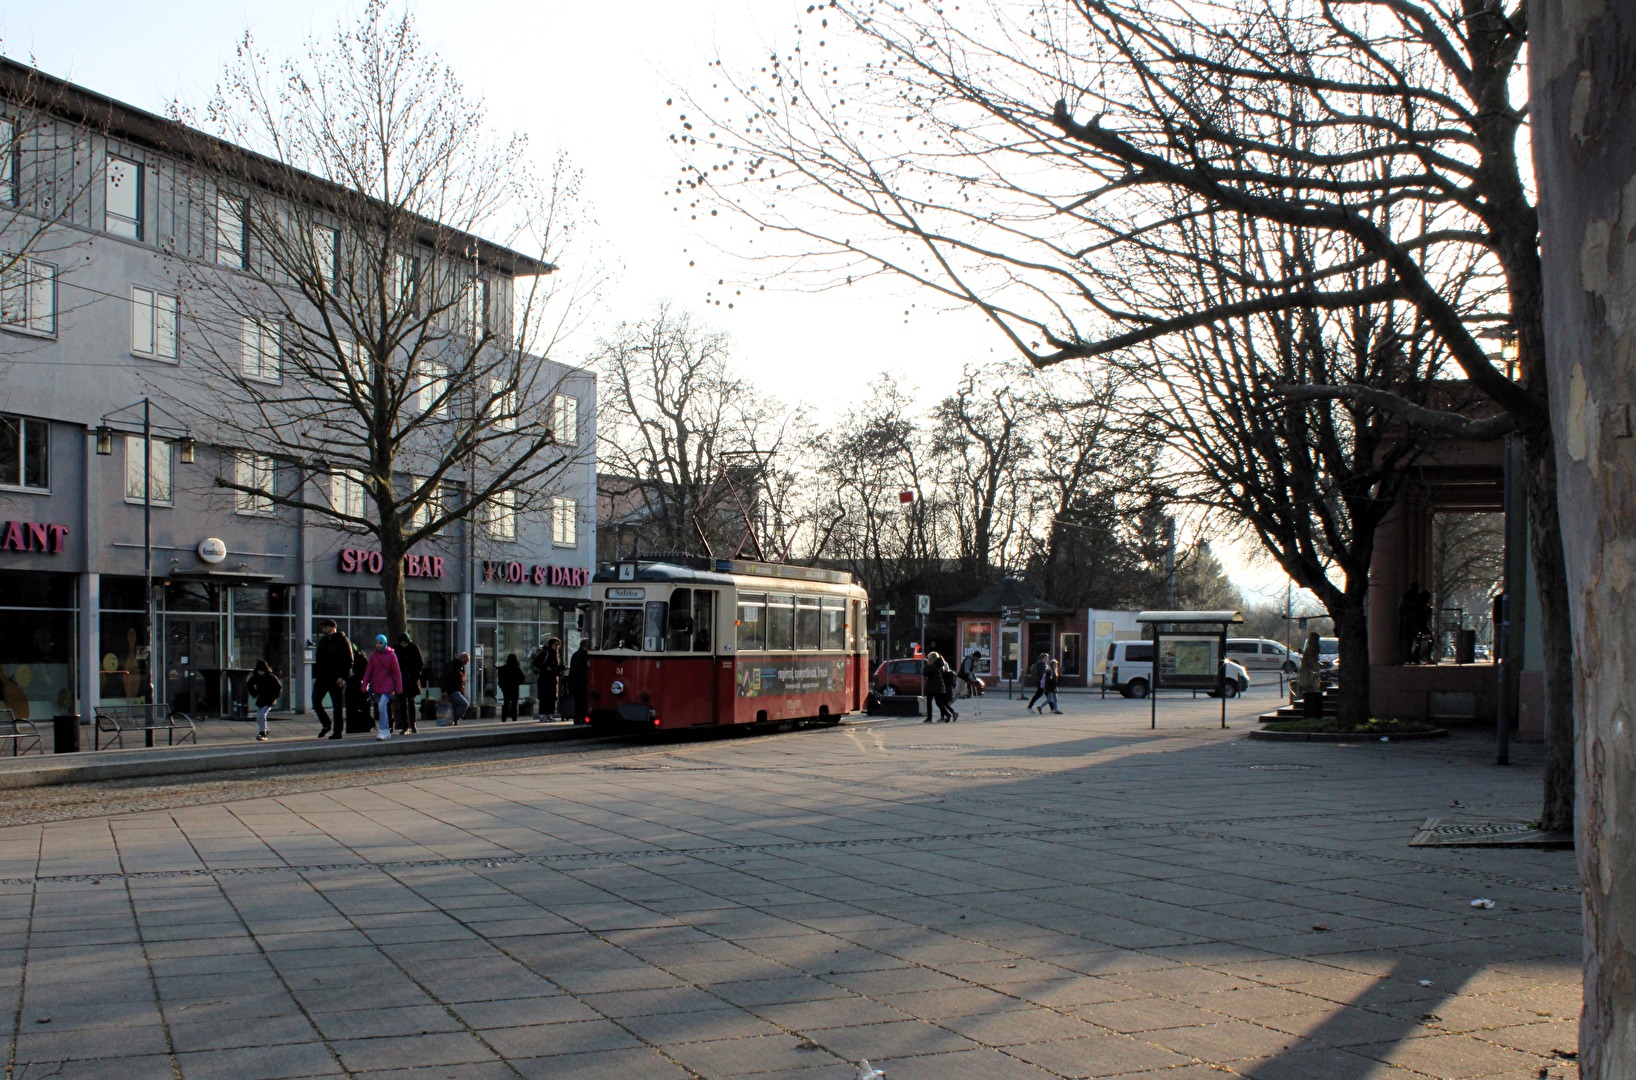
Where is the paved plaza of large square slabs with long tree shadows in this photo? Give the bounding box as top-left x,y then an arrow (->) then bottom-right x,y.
0,692 -> 1580,1080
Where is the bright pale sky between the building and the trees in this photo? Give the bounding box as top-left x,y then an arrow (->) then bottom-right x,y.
0,0 -> 1286,605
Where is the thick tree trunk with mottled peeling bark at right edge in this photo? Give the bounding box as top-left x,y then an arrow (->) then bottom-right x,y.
1528,0 -> 1636,1080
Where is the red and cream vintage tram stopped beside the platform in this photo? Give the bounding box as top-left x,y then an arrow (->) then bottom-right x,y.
587,556 -> 869,730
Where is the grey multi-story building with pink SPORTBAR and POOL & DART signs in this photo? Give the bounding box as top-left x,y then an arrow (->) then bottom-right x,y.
0,61 -> 596,718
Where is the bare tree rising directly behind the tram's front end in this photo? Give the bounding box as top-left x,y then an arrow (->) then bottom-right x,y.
594,304 -> 800,555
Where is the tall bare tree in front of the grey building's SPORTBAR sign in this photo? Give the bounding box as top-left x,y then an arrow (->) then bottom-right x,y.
159,0 -> 584,635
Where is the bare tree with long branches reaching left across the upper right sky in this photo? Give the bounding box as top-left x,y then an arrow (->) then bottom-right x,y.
676,0 -> 1572,826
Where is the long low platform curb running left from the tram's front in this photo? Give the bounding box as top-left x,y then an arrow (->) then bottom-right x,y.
0,725 -> 602,790
